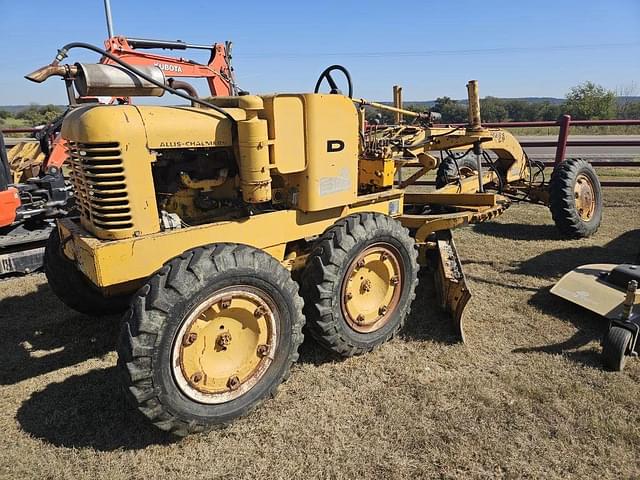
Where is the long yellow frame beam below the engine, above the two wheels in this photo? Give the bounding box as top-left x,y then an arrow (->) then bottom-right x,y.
58,190 -> 402,287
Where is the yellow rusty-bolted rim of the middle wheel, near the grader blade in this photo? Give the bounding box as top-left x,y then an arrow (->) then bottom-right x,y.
341,243 -> 404,333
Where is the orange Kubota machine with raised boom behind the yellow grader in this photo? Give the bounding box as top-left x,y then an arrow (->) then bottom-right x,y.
0,34 -> 238,275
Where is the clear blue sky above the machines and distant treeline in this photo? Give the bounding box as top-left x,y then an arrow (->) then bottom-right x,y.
0,0 -> 640,105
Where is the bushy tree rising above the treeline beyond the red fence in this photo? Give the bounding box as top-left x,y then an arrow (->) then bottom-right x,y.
564,82 -> 616,120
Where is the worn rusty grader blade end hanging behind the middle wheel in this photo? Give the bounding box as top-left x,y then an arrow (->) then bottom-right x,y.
434,230 -> 471,342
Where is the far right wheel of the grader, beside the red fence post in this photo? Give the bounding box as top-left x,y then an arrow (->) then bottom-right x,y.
549,158 -> 603,238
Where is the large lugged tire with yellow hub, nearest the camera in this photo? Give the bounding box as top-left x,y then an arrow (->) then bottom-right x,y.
117,243 -> 304,436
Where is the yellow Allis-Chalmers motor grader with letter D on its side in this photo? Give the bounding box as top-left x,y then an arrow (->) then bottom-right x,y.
25,44 -> 599,435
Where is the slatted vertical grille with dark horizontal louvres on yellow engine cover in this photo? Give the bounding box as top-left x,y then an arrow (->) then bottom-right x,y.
68,142 -> 133,230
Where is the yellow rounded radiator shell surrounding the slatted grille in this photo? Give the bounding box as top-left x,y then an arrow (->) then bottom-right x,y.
62,105 -> 161,239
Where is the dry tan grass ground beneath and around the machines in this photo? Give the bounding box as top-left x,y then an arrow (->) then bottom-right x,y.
0,189 -> 640,479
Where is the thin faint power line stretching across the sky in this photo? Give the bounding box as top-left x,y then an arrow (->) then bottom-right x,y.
235,42 -> 640,59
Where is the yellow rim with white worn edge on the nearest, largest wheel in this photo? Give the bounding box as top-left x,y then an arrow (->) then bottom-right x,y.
171,285 -> 279,404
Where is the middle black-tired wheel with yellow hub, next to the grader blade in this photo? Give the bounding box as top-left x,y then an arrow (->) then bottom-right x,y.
302,213 -> 418,357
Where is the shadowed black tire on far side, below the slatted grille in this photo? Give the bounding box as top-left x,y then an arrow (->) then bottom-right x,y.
44,228 -> 131,317
